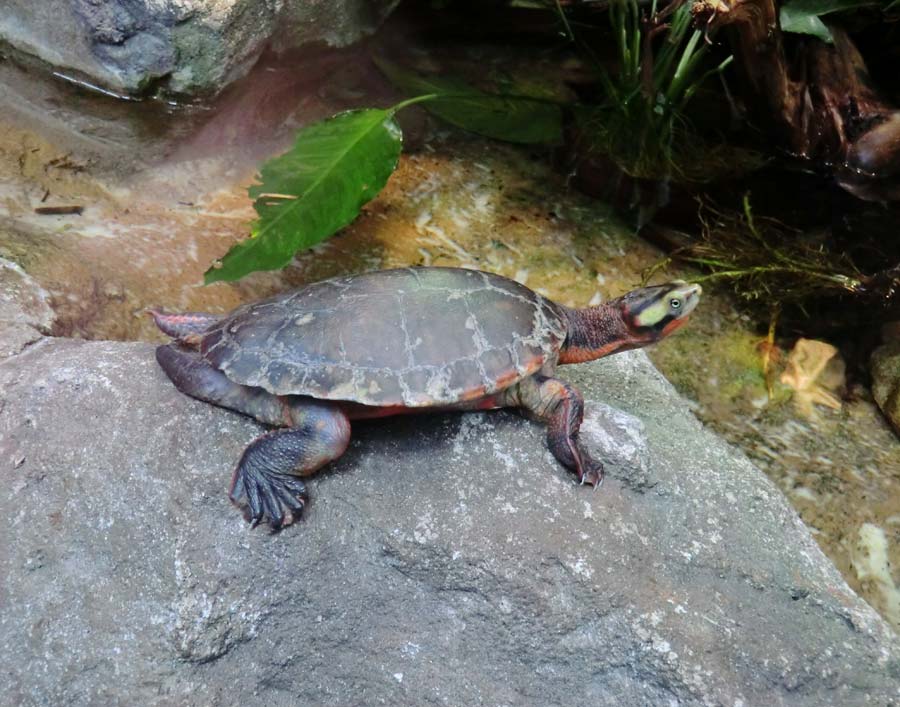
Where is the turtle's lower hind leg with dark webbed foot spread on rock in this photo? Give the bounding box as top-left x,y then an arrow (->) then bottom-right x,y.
229,400 -> 350,530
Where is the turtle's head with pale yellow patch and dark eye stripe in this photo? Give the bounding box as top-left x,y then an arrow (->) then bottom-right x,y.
610,280 -> 703,343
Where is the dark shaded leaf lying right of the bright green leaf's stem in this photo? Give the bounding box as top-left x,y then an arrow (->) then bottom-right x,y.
376,59 -> 562,145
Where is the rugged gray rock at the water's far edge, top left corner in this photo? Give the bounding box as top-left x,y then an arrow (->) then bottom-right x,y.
0,0 -> 398,94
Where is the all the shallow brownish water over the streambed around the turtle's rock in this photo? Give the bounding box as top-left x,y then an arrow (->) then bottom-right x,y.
0,31 -> 900,626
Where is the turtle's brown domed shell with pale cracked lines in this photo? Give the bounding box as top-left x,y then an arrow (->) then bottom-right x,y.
200,268 -> 566,407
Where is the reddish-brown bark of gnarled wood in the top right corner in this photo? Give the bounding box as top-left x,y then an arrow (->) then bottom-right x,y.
693,0 -> 900,200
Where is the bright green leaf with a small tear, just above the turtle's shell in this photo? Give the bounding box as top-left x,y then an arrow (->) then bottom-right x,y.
204,109 -> 402,284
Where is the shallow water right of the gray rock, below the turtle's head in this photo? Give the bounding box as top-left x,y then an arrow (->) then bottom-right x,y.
649,292 -> 900,627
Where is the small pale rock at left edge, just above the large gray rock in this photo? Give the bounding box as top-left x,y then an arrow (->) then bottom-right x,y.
0,258 -> 54,361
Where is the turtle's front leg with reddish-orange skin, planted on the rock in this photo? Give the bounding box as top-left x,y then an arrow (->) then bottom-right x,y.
512,375 -> 603,486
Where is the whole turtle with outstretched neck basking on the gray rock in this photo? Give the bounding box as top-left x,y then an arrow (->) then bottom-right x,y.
150,267 -> 701,530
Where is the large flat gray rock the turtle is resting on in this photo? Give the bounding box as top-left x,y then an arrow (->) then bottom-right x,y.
0,339 -> 900,706
